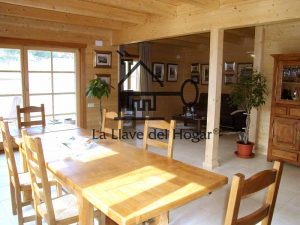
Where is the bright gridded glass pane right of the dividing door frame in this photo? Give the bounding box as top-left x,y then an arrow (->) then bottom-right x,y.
27,50 -> 76,123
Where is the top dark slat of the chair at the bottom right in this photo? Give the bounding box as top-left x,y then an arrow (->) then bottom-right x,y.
242,170 -> 277,196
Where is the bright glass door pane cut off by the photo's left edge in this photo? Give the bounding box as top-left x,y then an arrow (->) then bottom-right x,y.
0,48 -> 23,120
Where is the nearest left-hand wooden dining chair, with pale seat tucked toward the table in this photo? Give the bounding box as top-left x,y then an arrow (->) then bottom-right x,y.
22,129 -> 104,225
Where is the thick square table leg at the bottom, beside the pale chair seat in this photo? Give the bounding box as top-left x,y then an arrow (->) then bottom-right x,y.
78,196 -> 94,225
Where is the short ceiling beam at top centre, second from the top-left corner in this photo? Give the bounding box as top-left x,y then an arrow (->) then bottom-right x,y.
82,0 -> 177,16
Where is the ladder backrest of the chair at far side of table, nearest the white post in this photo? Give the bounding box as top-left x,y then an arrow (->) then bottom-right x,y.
143,120 -> 176,158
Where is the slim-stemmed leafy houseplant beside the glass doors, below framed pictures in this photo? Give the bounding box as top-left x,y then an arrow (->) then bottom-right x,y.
85,78 -> 113,131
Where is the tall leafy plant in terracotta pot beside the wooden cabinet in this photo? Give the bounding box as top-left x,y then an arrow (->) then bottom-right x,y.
230,71 -> 267,158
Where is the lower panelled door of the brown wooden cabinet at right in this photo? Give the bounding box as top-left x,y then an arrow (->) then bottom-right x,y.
272,117 -> 300,151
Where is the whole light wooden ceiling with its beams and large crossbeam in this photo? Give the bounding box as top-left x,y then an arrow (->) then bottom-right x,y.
0,0 -> 300,45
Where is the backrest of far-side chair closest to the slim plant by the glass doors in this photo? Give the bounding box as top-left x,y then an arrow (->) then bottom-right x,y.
101,109 -> 123,138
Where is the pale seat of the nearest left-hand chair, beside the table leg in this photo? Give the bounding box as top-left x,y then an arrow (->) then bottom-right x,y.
38,194 -> 78,223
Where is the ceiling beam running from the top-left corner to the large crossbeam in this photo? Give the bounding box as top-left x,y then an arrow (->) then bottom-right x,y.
0,0 -> 148,24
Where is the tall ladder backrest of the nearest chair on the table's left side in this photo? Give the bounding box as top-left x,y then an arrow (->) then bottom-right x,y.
22,129 -> 55,224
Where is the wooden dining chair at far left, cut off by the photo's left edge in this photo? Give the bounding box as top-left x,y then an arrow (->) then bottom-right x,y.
0,117 -> 35,225
